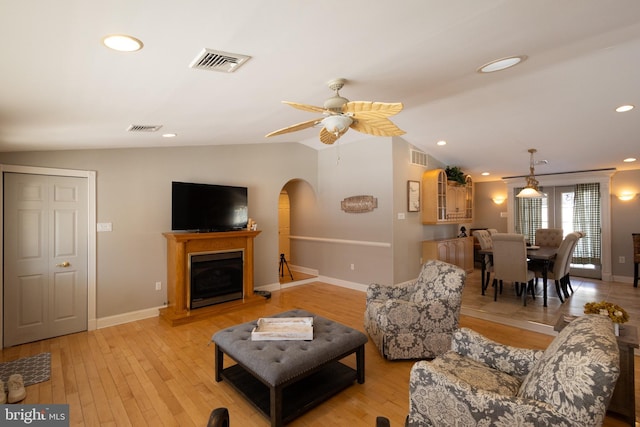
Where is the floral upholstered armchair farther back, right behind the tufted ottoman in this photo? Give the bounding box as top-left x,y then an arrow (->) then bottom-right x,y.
364,260 -> 466,360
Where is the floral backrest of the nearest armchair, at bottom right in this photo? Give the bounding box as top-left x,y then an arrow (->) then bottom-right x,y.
518,315 -> 620,425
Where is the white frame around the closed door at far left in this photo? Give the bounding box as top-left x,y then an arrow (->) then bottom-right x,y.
0,164 -> 98,343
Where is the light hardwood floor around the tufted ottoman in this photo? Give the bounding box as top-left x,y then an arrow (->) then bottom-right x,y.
0,282 -> 640,427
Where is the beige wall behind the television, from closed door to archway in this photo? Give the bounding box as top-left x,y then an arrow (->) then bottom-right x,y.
0,144 -> 317,318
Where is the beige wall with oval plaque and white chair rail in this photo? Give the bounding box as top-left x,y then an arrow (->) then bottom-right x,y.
288,137 -> 393,286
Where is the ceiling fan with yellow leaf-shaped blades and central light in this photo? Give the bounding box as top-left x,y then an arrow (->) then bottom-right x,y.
266,79 -> 405,144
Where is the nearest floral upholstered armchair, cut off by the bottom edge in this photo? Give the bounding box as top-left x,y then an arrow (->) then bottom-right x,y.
407,315 -> 620,427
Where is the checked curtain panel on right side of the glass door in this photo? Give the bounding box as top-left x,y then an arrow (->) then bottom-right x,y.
572,183 -> 602,265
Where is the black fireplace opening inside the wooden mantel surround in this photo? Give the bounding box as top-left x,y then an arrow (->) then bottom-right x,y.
189,251 -> 243,309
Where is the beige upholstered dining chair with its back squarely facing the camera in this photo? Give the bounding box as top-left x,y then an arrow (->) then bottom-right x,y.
491,233 -> 536,305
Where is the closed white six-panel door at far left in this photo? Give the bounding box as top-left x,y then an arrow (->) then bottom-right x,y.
3,173 -> 88,347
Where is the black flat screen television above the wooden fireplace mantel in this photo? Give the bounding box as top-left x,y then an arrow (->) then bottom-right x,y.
171,181 -> 248,232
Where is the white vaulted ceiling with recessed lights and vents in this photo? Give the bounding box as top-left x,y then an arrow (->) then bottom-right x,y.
0,0 -> 640,181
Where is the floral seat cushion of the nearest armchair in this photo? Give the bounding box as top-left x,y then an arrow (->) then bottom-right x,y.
431,351 -> 521,396
